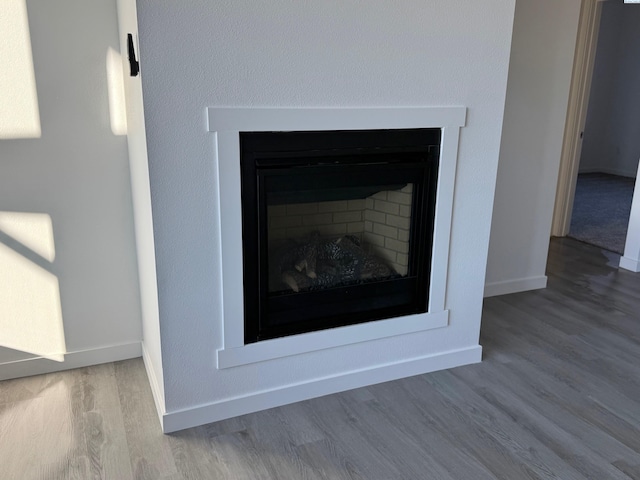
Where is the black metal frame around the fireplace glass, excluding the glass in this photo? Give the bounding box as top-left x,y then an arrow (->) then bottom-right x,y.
240,128 -> 441,344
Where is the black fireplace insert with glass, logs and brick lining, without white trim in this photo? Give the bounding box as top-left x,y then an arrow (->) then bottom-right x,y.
239,128 -> 441,344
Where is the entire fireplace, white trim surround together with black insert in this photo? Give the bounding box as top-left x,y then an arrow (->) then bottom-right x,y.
208,107 -> 466,370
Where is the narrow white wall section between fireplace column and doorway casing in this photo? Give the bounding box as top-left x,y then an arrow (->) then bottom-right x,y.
485,0 -> 581,296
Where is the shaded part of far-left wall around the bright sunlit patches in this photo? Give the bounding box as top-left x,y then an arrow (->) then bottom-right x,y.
0,0 -> 141,378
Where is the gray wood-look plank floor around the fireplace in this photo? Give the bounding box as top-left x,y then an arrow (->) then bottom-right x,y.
0,239 -> 640,480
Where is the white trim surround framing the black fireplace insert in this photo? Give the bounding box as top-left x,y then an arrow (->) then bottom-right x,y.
208,106 -> 466,369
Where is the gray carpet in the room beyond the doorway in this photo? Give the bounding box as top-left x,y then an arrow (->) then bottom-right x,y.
569,173 -> 635,254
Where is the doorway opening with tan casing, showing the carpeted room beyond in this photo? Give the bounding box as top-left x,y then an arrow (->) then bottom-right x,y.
552,0 -> 640,260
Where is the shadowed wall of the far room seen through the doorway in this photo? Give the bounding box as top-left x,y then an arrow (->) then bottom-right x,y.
580,0 -> 640,177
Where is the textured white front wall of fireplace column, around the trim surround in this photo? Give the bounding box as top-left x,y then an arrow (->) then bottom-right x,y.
138,0 -> 513,428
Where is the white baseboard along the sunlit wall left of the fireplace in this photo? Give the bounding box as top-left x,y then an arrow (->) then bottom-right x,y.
0,342 -> 142,380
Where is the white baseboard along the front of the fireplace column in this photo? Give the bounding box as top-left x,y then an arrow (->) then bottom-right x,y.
163,345 -> 482,433
